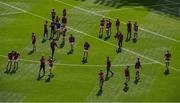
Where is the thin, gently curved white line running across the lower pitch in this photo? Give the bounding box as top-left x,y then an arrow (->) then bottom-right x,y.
0,55 -> 158,67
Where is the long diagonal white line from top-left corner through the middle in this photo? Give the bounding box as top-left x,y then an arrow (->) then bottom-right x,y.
0,1 -> 180,72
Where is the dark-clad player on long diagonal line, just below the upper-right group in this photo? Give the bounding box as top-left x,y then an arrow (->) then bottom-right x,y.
116,32 -> 123,53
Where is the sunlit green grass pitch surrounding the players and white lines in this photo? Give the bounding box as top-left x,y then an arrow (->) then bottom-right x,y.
0,0 -> 180,102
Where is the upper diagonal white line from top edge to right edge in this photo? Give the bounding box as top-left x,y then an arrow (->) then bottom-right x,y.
55,0 -> 180,43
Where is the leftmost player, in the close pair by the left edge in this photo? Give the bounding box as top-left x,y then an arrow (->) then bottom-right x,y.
4,51 -> 14,73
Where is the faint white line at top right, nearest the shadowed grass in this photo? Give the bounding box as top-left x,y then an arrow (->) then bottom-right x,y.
96,3 -> 180,13
